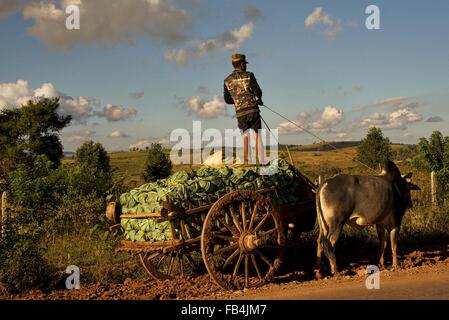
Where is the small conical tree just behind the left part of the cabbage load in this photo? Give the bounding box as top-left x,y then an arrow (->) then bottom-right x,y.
142,143 -> 172,182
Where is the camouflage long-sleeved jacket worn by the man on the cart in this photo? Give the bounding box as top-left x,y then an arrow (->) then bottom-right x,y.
224,70 -> 262,117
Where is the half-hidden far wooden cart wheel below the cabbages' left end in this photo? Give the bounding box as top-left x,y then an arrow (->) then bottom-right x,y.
139,250 -> 201,280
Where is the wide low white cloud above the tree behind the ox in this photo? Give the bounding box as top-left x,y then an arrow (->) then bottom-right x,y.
357,108 -> 423,130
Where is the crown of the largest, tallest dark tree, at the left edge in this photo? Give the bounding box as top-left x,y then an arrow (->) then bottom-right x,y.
0,98 -> 72,166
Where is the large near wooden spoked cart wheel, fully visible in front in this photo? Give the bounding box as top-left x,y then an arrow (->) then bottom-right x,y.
201,190 -> 285,290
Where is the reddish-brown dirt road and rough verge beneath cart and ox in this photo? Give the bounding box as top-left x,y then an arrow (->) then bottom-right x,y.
0,244 -> 449,300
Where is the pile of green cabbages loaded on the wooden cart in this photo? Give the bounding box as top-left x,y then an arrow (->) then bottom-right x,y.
120,159 -> 300,241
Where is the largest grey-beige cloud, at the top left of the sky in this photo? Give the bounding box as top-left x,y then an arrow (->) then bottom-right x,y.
21,0 -> 191,49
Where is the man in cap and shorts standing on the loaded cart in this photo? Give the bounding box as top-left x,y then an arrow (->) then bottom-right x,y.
224,54 -> 264,164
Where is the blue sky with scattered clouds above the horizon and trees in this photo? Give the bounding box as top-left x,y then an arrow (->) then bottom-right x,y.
0,0 -> 449,150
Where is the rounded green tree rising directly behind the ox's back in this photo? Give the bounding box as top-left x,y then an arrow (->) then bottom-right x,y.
357,128 -> 393,169
